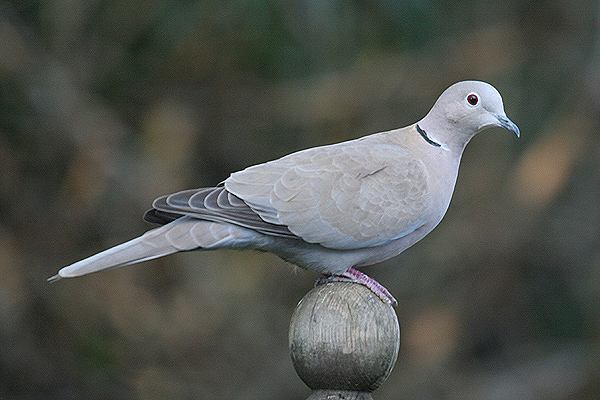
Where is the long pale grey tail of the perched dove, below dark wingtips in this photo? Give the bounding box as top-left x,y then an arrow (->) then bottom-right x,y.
48,217 -> 254,282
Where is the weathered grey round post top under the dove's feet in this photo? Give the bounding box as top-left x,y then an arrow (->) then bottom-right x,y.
289,282 -> 400,400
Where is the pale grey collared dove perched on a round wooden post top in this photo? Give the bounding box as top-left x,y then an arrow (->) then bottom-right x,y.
49,81 -> 519,303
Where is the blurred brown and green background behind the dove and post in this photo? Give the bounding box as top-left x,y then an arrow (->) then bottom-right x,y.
0,0 -> 600,400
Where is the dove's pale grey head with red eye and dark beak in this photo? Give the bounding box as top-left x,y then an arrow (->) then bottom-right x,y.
419,81 -> 520,149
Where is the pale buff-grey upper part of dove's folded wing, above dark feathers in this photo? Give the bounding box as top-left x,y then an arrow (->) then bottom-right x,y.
225,140 -> 428,249
